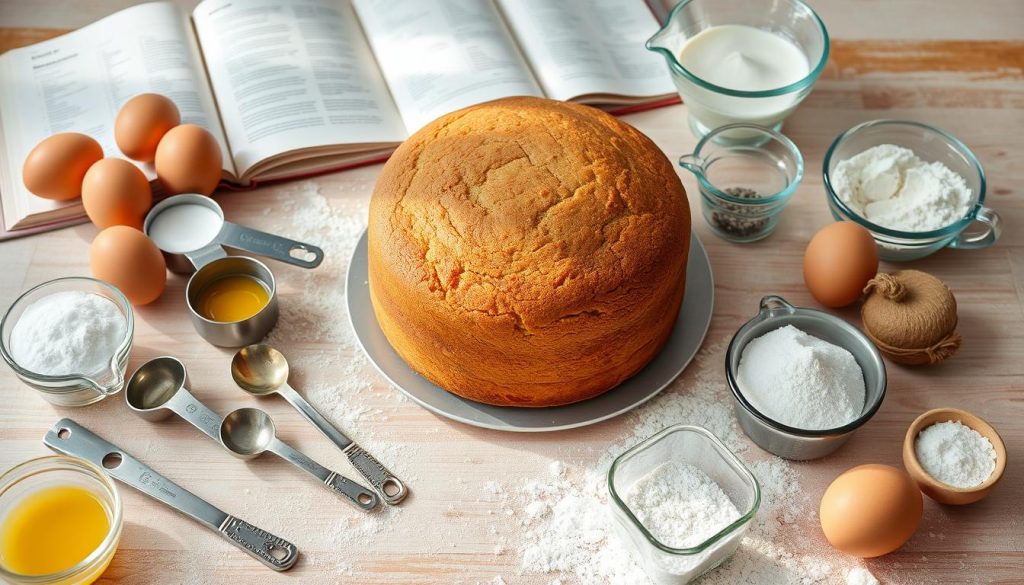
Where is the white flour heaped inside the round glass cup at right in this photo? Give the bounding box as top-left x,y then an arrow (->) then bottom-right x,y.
830,144 -> 972,232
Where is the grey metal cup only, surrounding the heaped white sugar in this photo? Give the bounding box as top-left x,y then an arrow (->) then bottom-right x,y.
725,295 -> 886,460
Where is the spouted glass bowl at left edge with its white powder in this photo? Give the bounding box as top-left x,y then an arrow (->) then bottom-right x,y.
0,277 -> 134,406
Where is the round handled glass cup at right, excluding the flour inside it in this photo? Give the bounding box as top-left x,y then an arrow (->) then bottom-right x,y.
822,120 -> 1001,261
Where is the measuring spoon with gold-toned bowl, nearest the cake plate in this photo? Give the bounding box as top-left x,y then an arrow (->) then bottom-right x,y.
231,343 -> 409,505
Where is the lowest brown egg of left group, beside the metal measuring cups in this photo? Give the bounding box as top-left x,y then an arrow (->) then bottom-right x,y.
89,225 -> 167,304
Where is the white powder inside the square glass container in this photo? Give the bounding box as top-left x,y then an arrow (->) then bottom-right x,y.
623,461 -> 741,548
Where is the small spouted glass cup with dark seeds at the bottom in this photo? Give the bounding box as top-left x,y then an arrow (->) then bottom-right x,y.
679,124 -> 804,243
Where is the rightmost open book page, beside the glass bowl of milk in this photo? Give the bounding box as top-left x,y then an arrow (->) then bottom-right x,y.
497,0 -> 676,99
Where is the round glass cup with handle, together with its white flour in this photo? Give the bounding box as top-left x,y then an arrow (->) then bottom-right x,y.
822,120 -> 1000,261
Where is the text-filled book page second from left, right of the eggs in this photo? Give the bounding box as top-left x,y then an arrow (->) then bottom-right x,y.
193,0 -> 406,175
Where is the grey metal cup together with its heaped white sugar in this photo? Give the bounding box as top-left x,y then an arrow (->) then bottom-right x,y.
726,295 -> 886,459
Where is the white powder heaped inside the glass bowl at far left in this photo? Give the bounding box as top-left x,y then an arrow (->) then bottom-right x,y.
10,291 -> 128,376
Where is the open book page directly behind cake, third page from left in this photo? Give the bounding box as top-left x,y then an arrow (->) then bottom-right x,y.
353,0 -> 544,133
